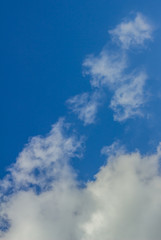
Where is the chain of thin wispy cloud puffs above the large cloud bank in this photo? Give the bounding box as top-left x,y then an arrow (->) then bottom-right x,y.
68,13 -> 153,125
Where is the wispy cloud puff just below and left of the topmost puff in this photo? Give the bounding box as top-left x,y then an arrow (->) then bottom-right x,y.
83,50 -> 127,88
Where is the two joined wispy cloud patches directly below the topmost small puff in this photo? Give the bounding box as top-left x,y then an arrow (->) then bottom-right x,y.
84,48 -> 147,121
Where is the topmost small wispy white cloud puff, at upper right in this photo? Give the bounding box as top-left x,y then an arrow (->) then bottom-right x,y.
109,13 -> 153,49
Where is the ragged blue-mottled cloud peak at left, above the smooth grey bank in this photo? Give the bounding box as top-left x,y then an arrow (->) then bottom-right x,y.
0,119 -> 81,195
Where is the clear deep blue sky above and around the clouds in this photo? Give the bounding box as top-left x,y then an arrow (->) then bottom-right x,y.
0,0 -> 161,178
